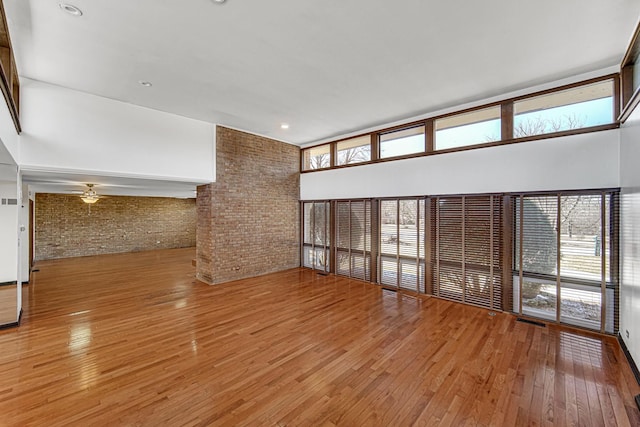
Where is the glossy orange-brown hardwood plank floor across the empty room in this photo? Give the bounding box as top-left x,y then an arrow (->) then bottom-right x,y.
0,249 -> 640,426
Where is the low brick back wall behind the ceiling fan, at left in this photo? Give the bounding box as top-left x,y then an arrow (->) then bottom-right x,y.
35,194 -> 196,260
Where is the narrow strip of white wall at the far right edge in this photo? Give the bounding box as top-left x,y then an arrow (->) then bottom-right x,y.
620,108 -> 640,372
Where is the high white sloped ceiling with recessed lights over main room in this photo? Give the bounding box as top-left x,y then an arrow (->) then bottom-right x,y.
4,0 -> 640,196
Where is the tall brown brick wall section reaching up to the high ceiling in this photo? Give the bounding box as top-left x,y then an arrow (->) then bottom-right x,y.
196,126 -> 300,284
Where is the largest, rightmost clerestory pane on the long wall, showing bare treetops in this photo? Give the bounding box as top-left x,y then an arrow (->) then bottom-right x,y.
513,80 -> 615,138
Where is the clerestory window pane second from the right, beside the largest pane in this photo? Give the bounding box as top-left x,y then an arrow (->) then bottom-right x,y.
434,105 -> 501,150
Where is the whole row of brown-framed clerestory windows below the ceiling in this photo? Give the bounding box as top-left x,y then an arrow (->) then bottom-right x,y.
302,76 -> 616,171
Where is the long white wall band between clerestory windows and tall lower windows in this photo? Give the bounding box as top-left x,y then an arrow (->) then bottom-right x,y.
300,129 -> 620,200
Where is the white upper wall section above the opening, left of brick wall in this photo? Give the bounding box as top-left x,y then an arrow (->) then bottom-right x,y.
18,79 -> 215,183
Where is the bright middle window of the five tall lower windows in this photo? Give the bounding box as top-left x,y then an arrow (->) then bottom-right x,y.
378,199 -> 425,293
